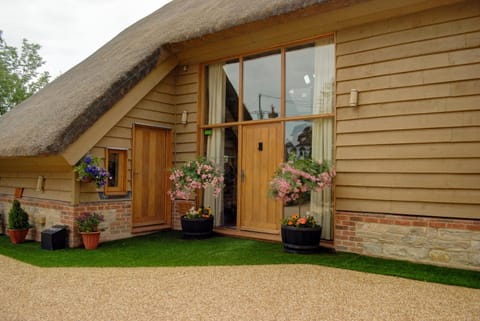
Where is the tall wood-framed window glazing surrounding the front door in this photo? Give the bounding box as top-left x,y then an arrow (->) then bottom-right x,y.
202,37 -> 335,239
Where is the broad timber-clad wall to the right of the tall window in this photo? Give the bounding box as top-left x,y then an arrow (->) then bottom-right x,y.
336,1 -> 480,218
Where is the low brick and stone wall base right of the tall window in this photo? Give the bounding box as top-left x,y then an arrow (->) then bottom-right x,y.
334,212 -> 480,270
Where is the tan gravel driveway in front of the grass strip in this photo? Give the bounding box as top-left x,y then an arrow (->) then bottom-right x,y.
0,255 -> 480,321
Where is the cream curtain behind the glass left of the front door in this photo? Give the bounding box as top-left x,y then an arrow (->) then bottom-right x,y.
203,64 -> 226,226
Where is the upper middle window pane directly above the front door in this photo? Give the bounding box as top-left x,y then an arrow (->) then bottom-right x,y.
243,52 -> 281,120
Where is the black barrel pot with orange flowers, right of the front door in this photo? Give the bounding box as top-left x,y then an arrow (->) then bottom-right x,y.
282,225 -> 322,254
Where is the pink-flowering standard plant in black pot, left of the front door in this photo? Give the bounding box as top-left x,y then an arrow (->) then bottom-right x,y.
168,158 -> 224,238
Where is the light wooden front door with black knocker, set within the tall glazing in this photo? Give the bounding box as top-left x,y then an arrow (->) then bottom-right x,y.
239,123 -> 283,234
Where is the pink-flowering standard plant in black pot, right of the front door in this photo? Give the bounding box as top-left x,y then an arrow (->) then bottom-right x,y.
270,154 -> 336,253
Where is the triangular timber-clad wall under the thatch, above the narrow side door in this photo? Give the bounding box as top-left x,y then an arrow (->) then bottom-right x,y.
80,70 -> 176,202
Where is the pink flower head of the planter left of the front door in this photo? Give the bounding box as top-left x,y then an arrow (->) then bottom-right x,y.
168,158 -> 224,200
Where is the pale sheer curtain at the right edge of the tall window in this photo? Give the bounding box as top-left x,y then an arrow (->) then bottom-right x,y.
310,38 -> 335,240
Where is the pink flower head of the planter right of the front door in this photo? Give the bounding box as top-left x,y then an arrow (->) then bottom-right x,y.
270,154 -> 336,205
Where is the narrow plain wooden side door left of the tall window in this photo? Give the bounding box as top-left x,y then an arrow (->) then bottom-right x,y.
132,125 -> 172,232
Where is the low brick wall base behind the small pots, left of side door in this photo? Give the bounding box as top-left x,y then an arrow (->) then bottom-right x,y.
0,196 -> 132,247
